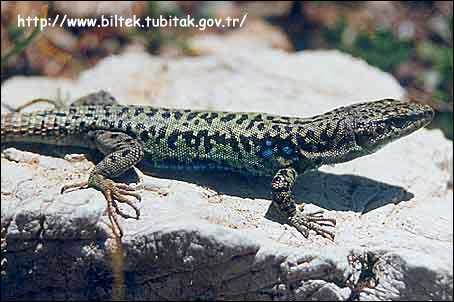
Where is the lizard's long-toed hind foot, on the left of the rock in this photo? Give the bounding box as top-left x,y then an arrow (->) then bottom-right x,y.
62,174 -> 141,238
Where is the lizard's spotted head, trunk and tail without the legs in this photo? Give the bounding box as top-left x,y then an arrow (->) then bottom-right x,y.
1,100 -> 433,175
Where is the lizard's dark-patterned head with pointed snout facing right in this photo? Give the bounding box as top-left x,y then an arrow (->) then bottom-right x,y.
350,99 -> 434,153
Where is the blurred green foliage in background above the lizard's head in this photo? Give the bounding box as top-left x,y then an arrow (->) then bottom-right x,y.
323,15 -> 453,139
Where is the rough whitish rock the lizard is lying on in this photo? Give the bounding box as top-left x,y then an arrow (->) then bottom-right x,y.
1,41 -> 453,300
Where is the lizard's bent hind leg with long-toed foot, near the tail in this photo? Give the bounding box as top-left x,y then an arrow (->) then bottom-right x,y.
62,130 -> 144,238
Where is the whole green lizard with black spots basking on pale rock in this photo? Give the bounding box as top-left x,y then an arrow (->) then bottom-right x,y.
1,91 -> 434,240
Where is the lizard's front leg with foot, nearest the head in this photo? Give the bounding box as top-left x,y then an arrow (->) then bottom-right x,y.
271,168 -> 336,240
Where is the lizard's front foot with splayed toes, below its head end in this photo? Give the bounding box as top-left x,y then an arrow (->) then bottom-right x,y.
289,205 -> 336,240
